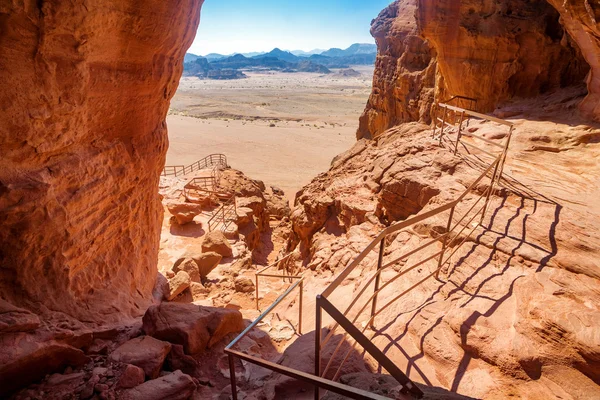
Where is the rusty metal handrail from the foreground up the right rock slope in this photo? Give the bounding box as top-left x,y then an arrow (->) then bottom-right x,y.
225,104 -> 513,400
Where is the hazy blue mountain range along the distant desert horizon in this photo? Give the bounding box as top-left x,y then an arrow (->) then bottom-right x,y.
184,43 -> 377,79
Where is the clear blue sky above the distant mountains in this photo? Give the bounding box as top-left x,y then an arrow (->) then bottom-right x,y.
189,0 -> 392,55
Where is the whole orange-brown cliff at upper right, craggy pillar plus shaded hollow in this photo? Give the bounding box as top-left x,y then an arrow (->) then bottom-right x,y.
357,0 -> 600,139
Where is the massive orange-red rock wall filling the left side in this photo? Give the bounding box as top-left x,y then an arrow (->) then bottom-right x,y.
0,0 -> 203,321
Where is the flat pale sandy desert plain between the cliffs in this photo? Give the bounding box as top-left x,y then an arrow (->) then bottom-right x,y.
167,67 -> 373,201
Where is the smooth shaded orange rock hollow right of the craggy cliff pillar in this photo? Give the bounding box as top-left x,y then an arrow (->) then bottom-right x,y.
417,0 -> 588,111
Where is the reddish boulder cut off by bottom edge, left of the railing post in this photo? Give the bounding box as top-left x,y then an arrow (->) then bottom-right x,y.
121,371 -> 196,400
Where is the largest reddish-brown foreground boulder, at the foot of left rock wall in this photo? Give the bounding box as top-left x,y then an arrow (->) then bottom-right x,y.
142,303 -> 244,354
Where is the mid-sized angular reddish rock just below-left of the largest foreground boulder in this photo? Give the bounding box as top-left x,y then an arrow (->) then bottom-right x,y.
110,336 -> 171,379
